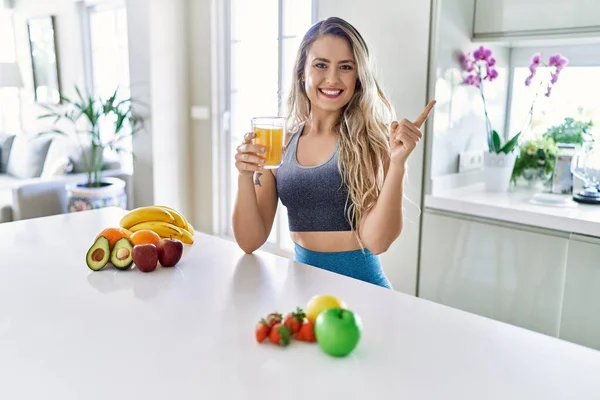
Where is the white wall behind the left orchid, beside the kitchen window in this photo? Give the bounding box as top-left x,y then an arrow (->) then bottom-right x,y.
428,0 -> 510,178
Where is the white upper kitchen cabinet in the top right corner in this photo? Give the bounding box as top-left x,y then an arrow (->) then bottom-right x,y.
473,0 -> 600,38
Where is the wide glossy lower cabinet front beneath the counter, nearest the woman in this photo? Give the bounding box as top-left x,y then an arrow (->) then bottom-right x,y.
419,210 -> 568,336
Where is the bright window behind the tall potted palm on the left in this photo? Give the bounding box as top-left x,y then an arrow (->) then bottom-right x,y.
84,0 -> 133,168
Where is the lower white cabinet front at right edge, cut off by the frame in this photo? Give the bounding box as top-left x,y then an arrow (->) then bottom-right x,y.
559,235 -> 600,350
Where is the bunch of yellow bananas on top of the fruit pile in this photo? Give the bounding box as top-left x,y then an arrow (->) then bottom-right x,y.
119,205 -> 194,244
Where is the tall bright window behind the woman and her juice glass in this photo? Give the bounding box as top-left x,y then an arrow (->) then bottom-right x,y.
224,0 -> 312,253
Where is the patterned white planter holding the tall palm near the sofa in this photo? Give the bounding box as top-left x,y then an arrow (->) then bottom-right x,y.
67,177 -> 127,212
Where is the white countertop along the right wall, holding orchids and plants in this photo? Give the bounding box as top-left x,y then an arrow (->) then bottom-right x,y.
425,184 -> 600,237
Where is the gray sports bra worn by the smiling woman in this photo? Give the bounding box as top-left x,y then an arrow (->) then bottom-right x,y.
276,127 -> 352,232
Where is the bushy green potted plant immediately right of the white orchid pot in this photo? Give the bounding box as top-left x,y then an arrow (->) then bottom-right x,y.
511,137 -> 558,183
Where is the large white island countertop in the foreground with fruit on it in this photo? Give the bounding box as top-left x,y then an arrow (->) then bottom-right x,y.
0,209 -> 600,400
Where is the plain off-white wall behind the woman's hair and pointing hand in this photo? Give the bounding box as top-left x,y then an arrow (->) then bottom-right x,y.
317,0 -> 430,294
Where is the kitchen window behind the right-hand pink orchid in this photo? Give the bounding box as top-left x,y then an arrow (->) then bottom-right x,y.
508,45 -> 600,139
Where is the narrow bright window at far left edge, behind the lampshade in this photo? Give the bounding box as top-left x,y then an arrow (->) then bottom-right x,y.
0,11 -> 23,133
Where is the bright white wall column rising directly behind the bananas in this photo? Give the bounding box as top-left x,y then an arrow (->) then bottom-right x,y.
149,0 -> 192,218
